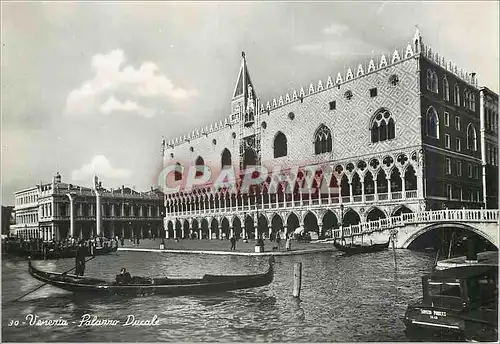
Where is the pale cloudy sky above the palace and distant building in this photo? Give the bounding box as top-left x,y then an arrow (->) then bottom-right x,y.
1,1 -> 500,205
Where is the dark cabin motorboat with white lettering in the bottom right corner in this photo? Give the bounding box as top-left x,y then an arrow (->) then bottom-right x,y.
403,265 -> 498,342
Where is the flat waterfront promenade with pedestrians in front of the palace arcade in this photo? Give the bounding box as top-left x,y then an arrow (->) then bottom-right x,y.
118,239 -> 336,256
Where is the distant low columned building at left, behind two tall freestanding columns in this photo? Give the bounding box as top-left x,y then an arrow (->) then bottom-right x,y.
10,173 -> 165,240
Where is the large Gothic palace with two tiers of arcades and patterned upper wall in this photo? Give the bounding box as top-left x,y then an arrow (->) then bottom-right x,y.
162,29 -> 496,242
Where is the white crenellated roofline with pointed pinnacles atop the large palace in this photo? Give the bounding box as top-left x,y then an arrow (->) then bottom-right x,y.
166,27 -> 478,148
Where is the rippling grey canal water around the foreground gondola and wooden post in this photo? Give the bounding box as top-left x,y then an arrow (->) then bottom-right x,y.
2,250 -> 434,342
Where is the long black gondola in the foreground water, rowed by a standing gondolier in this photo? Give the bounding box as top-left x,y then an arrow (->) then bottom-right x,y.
28,257 -> 274,296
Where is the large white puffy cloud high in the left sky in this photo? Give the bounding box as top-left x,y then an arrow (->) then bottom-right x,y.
65,49 -> 197,115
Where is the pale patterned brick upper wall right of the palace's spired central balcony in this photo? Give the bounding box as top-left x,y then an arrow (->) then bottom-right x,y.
256,58 -> 421,166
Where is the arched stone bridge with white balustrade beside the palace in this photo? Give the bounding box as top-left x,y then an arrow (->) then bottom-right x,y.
334,209 -> 499,248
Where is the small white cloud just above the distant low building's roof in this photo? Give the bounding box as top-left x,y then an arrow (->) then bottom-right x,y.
71,155 -> 132,181
